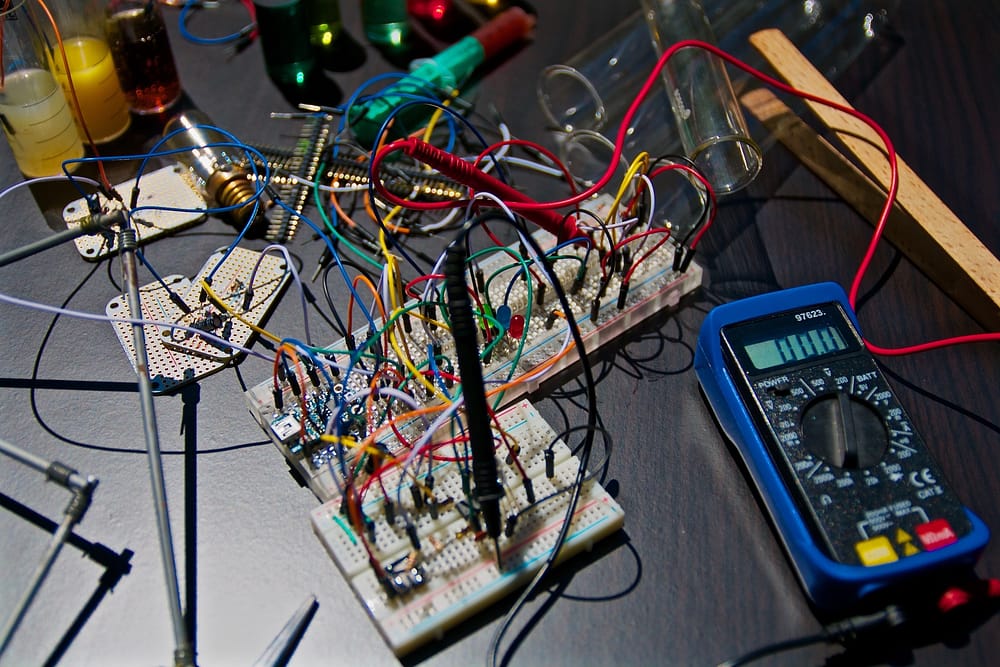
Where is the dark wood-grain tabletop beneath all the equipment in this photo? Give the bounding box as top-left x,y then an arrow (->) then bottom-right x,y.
0,1 -> 1000,665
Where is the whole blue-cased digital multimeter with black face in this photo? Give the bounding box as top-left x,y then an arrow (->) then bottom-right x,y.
694,283 -> 989,610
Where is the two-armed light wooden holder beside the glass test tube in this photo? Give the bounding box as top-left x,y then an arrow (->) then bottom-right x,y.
741,29 -> 1000,331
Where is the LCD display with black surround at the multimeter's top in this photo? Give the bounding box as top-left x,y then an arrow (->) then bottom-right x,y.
726,303 -> 860,371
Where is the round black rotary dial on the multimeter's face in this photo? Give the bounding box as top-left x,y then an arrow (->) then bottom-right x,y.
801,391 -> 889,470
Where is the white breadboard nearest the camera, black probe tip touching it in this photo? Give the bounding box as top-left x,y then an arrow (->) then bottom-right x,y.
312,400 -> 624,656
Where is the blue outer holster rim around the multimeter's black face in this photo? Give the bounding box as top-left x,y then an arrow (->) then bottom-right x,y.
694,282 -> 990,610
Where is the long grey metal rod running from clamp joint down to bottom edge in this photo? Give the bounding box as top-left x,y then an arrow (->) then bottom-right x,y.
118,227 -> 195,667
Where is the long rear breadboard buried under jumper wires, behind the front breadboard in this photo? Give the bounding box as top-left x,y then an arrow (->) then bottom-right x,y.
246,218 -> 702,501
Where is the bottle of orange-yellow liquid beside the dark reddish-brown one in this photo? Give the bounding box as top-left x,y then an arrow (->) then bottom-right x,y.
35,0 -> 131,144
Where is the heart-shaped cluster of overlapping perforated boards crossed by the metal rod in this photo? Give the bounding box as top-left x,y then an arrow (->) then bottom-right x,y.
105,248 -> 289,394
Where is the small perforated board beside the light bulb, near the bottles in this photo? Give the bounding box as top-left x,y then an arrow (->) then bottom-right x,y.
63,164 -> 206,262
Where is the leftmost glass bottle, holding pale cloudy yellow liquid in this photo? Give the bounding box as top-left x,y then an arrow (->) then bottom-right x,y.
0,3 -> 83,177
